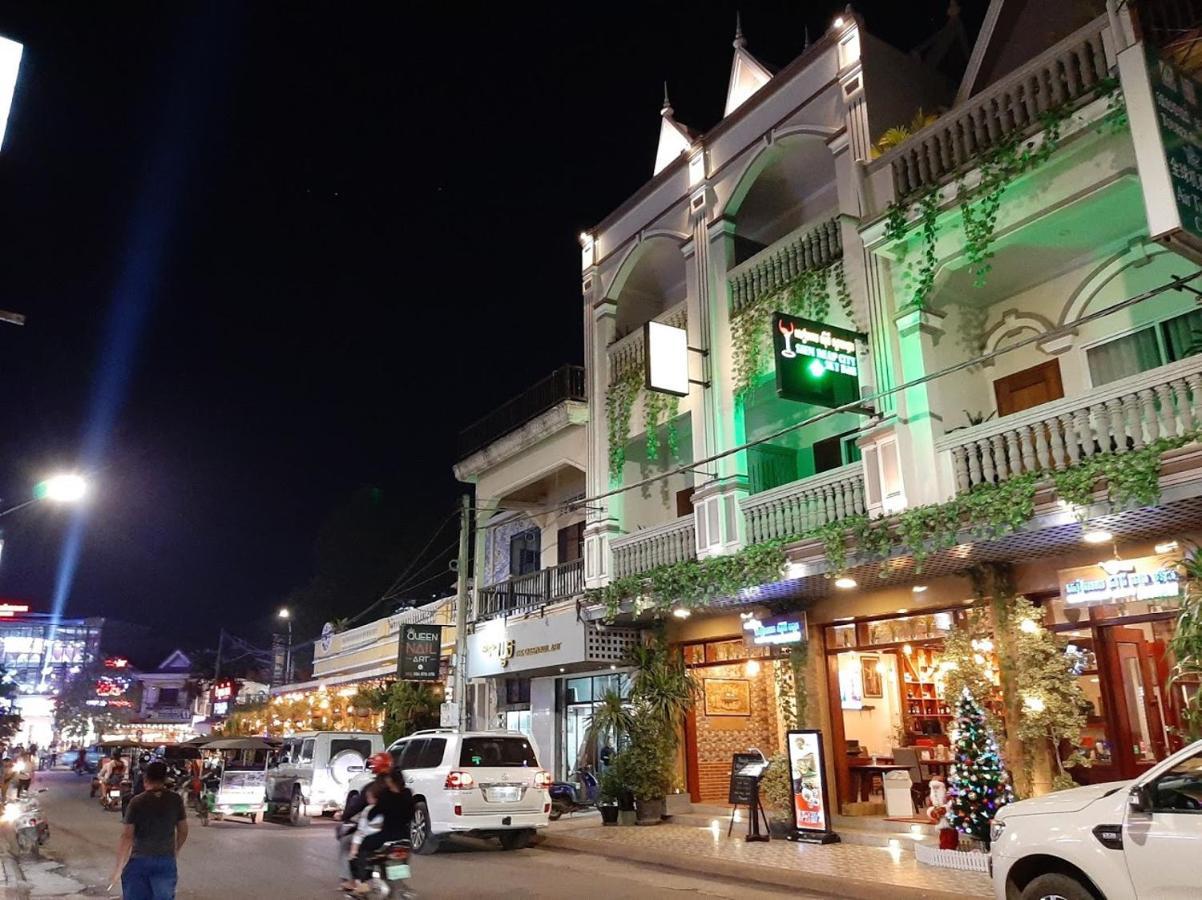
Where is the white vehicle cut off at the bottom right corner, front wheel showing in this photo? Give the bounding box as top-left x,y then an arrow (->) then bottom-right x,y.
990,740 -> 1202,900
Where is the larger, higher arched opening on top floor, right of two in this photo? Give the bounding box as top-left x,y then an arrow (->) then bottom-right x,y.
727,135 -> 838,266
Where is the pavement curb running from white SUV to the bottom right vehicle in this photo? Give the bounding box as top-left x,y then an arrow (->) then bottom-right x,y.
535,833 -> 980,900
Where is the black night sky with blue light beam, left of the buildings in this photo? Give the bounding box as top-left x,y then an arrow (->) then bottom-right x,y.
0,0 -> 983,643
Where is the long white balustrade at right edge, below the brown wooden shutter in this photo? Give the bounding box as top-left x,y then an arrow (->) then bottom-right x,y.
935,356 -> 1202,494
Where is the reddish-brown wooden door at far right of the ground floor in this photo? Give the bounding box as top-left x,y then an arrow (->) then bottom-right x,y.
1100,626 -> 1168,779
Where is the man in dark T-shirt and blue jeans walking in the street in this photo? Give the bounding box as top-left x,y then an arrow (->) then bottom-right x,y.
109,762 -> 188,900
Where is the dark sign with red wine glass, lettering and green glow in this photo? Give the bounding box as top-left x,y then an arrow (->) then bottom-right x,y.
772,312 -> 859,407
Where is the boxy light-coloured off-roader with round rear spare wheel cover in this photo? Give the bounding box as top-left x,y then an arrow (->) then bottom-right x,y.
264,732 -> 383,826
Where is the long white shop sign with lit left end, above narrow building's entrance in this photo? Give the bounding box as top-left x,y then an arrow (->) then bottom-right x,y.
468,610 -> 584,678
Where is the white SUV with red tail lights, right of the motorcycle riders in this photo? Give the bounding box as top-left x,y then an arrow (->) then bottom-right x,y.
346,728 -> 552,853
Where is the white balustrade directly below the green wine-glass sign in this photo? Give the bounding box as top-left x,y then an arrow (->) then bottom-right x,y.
743,463 -> 865,543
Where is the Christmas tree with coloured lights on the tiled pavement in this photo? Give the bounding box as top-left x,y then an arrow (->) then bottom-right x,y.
947,689 -> 1014,841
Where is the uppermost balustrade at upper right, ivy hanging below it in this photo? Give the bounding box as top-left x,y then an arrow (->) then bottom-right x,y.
869,16 -> 1114,198
